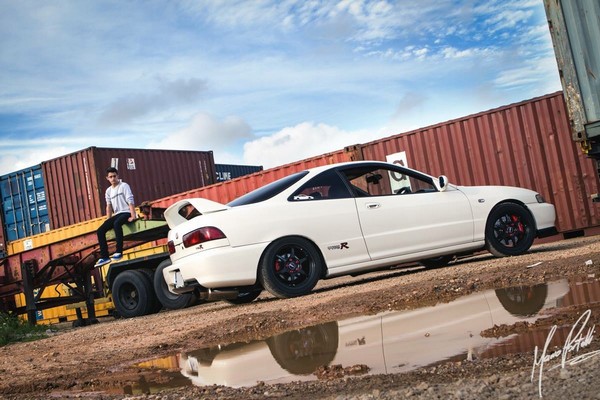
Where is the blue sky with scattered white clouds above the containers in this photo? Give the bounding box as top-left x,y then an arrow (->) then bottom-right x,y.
0,0 -> 561,175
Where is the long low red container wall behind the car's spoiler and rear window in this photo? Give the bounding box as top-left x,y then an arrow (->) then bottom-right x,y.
151,150 -> 351,208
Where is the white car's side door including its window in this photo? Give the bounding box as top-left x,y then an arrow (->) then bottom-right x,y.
342,165 -> 473,260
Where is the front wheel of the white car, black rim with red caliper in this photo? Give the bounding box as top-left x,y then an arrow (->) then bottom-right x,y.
485,203 -> 536,257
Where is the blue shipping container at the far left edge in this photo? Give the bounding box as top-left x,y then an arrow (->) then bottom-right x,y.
0,165 -> 50,242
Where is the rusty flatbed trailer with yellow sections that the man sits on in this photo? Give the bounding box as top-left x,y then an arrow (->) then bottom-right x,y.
0,210 -> 202,324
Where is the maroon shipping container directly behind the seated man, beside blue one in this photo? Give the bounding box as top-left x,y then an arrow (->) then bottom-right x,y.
42,147 -> 215,229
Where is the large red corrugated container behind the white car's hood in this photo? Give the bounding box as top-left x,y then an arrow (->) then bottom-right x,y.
359,92 -> 600,232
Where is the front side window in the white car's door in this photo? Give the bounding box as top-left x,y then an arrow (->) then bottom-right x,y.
344,166 -> 437,197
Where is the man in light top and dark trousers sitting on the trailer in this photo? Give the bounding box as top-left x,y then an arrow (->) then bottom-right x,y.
95,167 -> 136,267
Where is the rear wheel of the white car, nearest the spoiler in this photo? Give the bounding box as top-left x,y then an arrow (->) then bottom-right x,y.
259,237 -> 323,298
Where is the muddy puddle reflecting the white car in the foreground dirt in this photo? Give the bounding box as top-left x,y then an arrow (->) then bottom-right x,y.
126,277 -> 600,393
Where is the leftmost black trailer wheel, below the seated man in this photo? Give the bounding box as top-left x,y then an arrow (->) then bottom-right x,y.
112,270 -> 154,318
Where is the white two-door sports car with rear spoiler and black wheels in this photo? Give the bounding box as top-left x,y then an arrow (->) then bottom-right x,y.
163,161 -> 556,304
